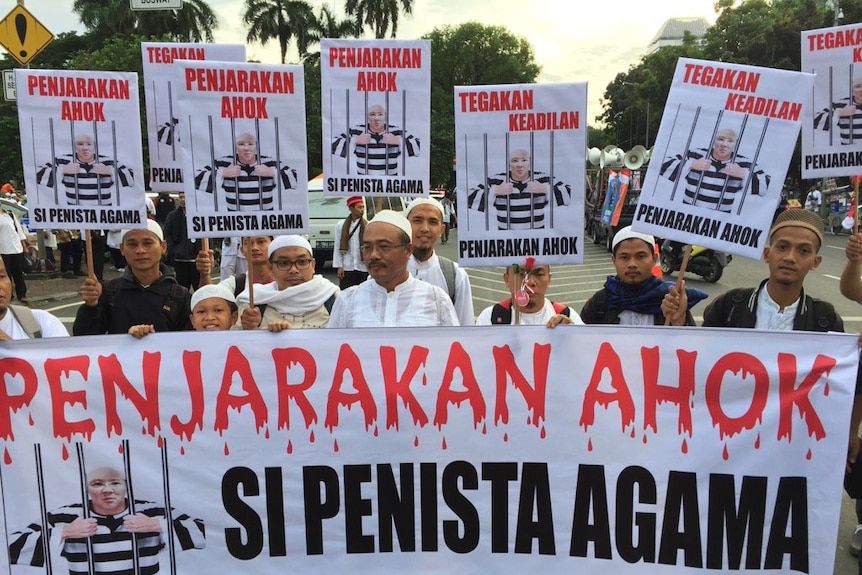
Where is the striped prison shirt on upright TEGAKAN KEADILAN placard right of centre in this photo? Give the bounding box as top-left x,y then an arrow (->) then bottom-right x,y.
467,172 -> 572,230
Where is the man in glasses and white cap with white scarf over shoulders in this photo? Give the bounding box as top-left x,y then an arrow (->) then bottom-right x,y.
236,235 -> 340,329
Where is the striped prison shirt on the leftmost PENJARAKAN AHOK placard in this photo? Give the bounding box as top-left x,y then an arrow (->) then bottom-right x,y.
36,154 -> 134,206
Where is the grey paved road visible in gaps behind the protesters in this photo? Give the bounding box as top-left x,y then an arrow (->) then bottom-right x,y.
37,231 -> 862,575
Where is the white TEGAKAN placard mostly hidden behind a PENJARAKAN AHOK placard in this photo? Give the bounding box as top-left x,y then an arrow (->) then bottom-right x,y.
141,42 -> 245,192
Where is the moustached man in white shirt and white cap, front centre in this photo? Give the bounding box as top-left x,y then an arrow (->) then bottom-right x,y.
327,210 -> 458,328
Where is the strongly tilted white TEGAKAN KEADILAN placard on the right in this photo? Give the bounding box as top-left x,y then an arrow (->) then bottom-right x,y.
632,58 -> 814,259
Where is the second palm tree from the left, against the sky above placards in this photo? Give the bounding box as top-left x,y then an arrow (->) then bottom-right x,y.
242,0 -> 316,64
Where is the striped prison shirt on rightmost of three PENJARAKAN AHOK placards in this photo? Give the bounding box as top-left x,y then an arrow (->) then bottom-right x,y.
332,124 -> 419,176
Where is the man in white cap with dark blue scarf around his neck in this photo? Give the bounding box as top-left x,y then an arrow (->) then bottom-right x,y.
581,226 -> 706,325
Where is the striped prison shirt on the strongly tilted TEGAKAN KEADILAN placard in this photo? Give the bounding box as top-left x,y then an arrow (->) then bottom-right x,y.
660,148 -> 770,213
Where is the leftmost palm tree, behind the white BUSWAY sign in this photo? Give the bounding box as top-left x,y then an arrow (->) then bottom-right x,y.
72,0 -> 218,42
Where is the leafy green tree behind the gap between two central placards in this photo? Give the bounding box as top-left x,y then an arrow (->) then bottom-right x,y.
423,22 -> 541,185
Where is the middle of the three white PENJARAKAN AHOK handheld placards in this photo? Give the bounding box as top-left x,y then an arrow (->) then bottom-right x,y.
174,60 -> 308,238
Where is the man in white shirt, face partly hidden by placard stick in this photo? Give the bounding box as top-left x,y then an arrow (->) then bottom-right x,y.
476,258 -> 584,327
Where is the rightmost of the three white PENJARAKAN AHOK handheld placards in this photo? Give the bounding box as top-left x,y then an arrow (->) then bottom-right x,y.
320,39 -> 431,197
